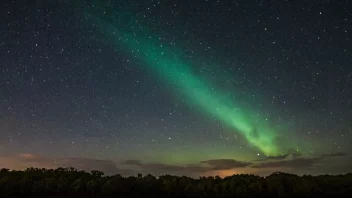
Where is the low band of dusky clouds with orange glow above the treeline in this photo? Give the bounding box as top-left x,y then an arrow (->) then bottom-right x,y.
0,153 -> 351,178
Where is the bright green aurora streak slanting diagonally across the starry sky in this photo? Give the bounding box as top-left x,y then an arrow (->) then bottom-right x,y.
89,10 -> 280,155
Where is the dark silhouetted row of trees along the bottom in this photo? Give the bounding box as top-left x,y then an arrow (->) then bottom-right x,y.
0,168 -> 352,198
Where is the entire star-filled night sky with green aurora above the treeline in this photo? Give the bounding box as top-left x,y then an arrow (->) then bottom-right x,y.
0,0 -> 352,177
